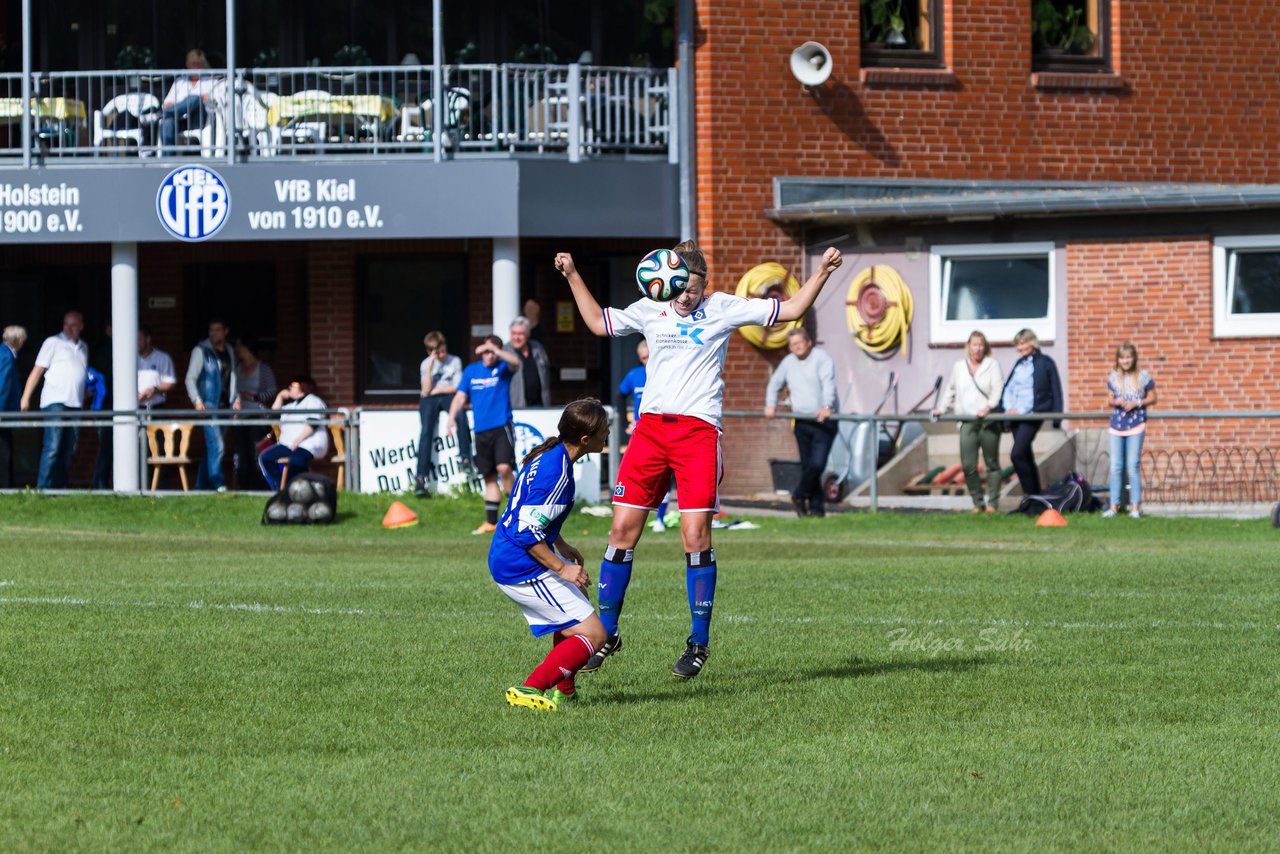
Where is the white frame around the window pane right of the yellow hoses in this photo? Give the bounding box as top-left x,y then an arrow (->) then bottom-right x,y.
929,242 -> 1059,344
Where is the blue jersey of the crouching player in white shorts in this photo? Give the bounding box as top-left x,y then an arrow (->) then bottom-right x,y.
489,444 -> 573,584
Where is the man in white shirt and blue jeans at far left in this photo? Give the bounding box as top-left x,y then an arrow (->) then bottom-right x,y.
19,311 -> 88,489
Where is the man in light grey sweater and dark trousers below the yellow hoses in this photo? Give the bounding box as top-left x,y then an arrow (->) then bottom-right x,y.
764,326 -> 838,517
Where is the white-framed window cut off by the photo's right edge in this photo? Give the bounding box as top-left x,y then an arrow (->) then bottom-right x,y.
1213,234 -> 1280,338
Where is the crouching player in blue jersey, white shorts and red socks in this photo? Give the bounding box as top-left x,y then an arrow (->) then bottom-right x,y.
489,398 -> 609,712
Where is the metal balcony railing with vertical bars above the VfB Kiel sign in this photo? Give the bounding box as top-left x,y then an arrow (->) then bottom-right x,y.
0,64 -> 677,164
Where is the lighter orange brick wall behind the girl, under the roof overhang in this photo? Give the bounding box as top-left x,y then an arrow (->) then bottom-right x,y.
1066,238 -> 1280,449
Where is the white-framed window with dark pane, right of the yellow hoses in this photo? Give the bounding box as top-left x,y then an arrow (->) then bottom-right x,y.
929,243 -> 1057,344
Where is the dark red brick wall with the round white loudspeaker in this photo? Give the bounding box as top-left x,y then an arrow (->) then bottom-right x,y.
696,0 -> 1280,494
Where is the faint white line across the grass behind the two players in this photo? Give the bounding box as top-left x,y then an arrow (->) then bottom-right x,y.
0,597 -> 1280,631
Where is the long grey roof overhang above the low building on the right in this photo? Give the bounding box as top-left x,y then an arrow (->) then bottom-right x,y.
764,178 -> 1280,225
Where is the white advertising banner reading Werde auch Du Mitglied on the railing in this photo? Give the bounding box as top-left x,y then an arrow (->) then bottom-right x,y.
360,408 -> 613,504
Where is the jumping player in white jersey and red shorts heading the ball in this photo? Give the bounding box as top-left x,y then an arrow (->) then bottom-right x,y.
556,241 -> 841,679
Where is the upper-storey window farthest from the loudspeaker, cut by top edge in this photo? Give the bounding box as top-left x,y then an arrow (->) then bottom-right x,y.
1032,0 -> 1111,72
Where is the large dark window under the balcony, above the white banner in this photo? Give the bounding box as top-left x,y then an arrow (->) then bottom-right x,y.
358,256 -> 475,396
